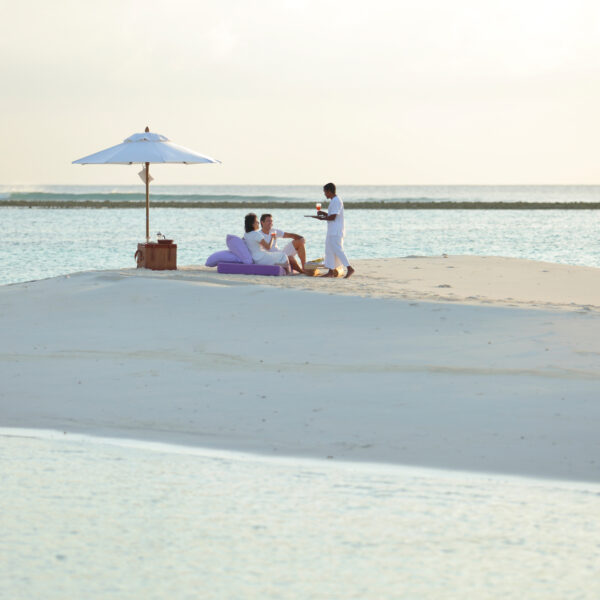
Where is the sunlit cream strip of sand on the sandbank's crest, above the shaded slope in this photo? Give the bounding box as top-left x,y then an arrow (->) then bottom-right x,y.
184,255 -> 600,311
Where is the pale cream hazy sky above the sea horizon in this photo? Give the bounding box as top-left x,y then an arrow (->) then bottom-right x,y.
0,0 -> 600,185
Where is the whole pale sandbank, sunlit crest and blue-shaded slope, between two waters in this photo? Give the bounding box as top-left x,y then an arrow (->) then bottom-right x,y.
0,257 -> 600,481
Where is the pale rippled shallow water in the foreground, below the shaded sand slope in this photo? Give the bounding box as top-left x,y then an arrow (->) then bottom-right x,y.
0,429 -> 600,600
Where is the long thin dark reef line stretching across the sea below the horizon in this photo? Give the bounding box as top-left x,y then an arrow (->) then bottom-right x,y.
0,199 -> 600,212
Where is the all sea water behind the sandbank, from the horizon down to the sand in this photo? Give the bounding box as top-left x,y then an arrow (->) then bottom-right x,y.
0,186 -> 600,284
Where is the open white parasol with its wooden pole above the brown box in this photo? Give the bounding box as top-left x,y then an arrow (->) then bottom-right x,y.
73,127 -> 221,242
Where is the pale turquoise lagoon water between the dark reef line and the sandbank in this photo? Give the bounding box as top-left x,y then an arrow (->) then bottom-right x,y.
0,207 -> 600,285
